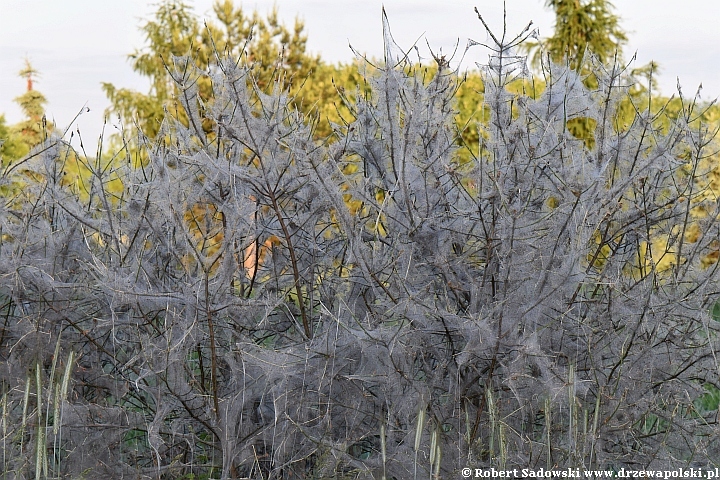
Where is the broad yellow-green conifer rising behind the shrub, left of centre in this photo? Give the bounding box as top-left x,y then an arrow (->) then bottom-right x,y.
103,0 -> 320,138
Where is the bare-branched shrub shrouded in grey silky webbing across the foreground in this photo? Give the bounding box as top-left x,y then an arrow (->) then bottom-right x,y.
0,13 -> 720,479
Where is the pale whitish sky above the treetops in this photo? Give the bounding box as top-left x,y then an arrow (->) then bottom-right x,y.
0,0 -> 720,148
